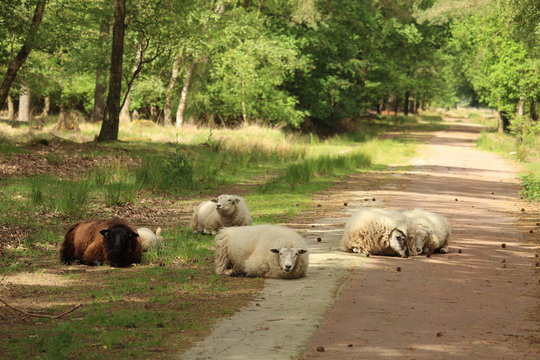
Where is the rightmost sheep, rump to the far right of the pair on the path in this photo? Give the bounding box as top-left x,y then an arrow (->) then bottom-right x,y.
403,208 -> 451,255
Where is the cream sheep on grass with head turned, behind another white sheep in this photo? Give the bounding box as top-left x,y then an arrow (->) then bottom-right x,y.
191,195 -> 252,235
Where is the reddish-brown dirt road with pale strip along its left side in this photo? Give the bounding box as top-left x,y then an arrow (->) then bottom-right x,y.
179,124 -> 540,360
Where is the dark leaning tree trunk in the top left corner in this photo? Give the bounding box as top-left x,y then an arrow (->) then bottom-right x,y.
0,0 -> 47,109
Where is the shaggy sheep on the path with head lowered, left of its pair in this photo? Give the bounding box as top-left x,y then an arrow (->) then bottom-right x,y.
341,207 -> 409,257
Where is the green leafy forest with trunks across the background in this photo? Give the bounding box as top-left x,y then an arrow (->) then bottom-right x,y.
0,0 -> 540,141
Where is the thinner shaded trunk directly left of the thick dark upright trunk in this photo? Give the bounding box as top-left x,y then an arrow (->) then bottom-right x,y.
92,19 -> 110,122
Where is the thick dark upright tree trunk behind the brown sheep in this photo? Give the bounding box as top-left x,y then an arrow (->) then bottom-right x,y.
97,0 -> 126,141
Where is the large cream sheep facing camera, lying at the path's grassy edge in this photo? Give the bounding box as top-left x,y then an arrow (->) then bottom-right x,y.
215,224 -> 309,279
